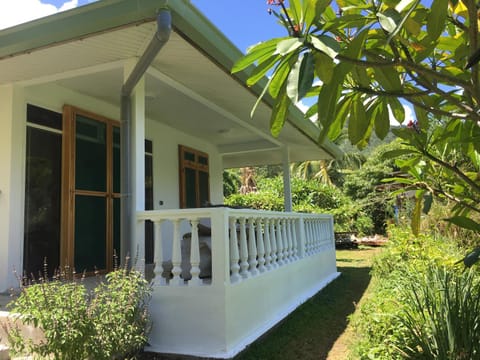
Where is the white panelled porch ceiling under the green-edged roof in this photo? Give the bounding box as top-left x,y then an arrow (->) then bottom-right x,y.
0,16 -> 338,167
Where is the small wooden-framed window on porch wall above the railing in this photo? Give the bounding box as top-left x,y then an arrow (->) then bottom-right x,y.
178,145 -> 210,208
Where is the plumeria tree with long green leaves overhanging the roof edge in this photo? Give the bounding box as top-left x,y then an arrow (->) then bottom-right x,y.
232,0 -> 480,242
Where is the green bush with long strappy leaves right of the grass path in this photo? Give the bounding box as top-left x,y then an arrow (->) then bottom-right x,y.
351,227 -> 480,360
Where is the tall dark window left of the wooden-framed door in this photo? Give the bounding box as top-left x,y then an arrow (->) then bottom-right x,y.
23,104 -> 63,277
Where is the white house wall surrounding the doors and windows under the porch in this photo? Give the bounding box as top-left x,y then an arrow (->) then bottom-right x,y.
0,84 -> 223,292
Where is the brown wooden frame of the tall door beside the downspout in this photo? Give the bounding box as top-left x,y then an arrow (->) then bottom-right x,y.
60,105 -> 121,272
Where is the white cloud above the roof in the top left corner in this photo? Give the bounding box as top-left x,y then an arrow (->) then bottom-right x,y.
0,0 -> 78,29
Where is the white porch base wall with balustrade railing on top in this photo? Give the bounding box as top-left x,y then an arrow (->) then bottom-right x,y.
137,207 -> 339,358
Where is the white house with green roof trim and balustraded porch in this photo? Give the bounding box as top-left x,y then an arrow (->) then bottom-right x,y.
0,0 -> 341,358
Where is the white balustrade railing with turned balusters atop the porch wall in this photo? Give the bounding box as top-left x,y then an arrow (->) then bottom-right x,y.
137,207 -> 334,286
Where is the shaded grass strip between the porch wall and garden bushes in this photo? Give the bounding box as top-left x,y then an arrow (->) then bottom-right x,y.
235,248 -> 380,360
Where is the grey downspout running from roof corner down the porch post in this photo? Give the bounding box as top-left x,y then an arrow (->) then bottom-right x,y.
120,9 -> 172,261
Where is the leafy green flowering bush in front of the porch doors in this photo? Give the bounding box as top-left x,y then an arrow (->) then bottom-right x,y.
8,267 -> 151,360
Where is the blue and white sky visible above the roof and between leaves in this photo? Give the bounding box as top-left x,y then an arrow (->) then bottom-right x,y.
0,0 -> 412,121
